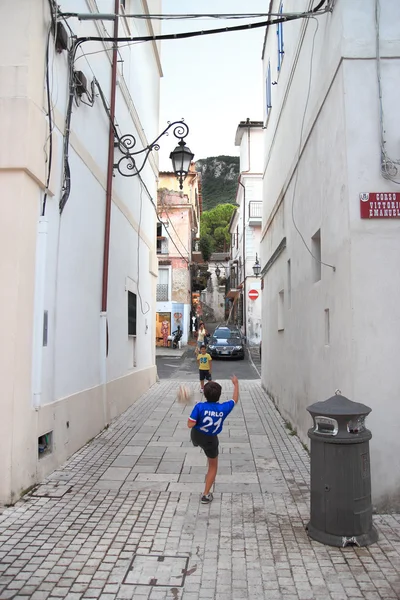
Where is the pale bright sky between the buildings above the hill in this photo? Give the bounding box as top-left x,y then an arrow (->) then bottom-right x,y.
160,0 -> 269,170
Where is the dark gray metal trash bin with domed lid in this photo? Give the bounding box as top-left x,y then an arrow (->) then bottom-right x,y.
307,393 -> 378,547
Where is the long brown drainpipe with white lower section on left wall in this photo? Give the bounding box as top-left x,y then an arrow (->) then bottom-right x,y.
100,0 -> 120,424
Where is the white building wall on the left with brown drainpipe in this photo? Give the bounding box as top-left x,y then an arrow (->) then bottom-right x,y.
0,0 -> 162,503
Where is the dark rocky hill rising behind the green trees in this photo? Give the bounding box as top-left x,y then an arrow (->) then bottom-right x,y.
196,156 -> 239,210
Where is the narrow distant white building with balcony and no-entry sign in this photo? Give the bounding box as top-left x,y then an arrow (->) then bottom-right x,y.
227,119 -> 263,345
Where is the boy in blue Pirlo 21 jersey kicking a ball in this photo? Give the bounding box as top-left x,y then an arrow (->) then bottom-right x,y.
188,375 -> 239,504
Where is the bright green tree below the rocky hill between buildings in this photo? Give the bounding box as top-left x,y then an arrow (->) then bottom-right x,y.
200,204 -> 236,251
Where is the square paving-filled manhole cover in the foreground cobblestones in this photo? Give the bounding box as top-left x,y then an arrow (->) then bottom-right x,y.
123,554 -> 189,587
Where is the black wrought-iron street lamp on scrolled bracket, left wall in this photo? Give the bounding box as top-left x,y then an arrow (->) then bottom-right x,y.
114,120 -> 194,189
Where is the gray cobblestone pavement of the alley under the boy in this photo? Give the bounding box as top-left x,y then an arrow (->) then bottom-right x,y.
0,380 -> 400,600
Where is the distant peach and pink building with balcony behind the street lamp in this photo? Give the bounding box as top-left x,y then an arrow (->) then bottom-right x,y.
155,168 -> 201,346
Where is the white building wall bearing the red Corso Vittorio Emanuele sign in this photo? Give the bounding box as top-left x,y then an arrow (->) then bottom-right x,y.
262,0 -> 400,509
